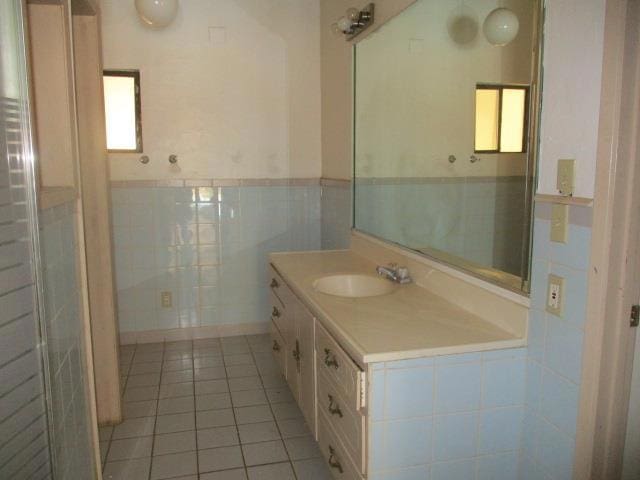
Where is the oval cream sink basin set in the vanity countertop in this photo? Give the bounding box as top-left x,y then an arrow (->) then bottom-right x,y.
313,274 -> 396,298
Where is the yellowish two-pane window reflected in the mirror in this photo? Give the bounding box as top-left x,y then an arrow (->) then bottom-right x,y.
475,85 -> 528,153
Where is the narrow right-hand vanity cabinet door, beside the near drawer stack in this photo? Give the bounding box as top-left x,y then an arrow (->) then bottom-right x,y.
296,304 -> 316,437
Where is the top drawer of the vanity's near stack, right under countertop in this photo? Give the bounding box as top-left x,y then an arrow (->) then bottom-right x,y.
316,322 -> 365,411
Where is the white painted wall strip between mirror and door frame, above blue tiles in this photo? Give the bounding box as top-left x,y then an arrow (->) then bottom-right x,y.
538,0 -> 605,198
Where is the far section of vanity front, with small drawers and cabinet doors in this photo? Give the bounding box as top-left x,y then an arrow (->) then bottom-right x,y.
269,269 -> 316,436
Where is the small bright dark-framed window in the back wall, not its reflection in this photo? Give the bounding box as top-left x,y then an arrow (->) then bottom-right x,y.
103,72 -> 142,152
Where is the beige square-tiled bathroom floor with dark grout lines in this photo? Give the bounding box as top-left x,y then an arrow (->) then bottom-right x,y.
100,335 -> 331,480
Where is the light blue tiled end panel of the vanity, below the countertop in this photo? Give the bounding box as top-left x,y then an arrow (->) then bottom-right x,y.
368,348 -> 527,480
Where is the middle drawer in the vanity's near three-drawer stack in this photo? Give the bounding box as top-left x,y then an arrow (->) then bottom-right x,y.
317,372 -> 366,473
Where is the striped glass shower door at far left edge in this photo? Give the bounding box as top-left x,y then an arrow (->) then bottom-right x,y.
0,0 -> 52,480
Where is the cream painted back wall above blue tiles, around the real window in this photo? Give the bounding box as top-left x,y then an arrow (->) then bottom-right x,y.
102,0 -> 321,180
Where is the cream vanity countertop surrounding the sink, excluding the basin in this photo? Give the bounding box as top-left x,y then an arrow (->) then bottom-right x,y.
270,250 -> 526,367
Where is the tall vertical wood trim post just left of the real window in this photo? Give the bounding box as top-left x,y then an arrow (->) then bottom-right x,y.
73,11 -> 122,424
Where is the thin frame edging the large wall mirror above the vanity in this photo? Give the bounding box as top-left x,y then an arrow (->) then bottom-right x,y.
351,0 -> 546,297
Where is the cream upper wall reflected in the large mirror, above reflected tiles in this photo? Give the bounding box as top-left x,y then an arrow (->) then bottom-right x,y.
355,0 -> 536,177
